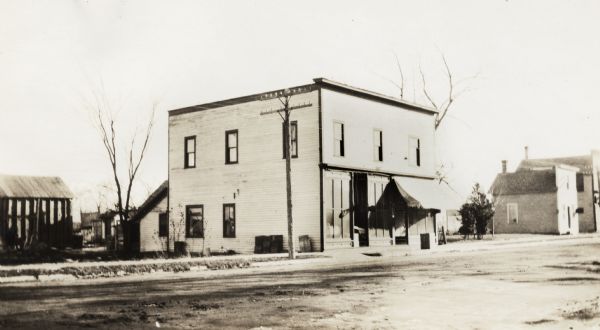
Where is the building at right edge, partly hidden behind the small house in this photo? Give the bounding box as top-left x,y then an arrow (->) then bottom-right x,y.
518,150 -> 600,233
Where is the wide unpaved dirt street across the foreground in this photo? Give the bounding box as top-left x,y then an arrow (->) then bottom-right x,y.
0,239 -> 600,329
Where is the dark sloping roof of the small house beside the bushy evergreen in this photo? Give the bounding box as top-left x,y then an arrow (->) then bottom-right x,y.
490,169 -> 557,196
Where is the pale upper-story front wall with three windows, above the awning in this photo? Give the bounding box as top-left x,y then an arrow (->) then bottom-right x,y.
321,89 -> 435,176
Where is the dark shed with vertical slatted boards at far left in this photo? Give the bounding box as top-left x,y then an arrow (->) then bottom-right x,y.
0,175 -> 73,248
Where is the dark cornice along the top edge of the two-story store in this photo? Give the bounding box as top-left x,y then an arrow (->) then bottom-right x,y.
169,78 -> 438,116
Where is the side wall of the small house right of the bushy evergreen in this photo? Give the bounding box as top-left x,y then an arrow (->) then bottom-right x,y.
493,192 -> 559,234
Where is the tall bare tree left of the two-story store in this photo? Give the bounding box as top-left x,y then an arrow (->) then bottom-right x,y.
92,93 -> 157,251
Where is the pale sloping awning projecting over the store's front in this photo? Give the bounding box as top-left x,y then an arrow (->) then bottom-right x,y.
393,177 -> 461,210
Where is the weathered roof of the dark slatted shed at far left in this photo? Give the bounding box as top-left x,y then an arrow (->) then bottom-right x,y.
0,175 -> 74,199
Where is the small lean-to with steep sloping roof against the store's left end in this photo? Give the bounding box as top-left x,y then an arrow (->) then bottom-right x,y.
130,181 -> 169,252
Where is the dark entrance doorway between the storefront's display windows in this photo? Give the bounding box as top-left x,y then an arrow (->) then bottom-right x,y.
352,173 -> 369,246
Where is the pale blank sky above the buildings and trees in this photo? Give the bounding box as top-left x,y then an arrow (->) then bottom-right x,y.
0,0 -> 600,210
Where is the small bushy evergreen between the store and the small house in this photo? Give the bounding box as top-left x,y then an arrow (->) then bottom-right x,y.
458,183 -> 494,239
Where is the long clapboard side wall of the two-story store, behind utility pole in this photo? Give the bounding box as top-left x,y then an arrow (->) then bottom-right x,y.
169,91 -> 320,253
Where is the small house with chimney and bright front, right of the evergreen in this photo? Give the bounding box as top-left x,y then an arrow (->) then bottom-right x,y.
490,162 -> 579,234
